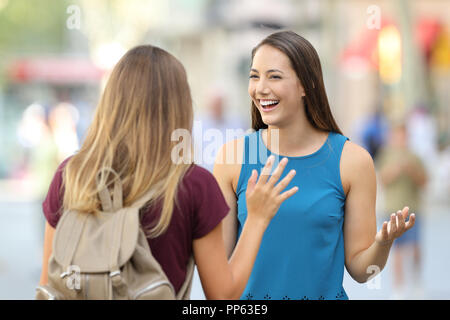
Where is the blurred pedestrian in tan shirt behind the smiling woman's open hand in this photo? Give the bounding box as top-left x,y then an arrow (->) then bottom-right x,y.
377,123 -> 427,299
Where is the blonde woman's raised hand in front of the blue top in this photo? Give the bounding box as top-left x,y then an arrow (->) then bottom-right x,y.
245,155 -> 298,224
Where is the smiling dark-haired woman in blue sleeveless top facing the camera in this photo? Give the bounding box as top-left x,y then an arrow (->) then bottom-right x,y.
214,31 -> 414,300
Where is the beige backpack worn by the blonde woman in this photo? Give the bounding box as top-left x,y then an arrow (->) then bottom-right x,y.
36,169 -> 194,300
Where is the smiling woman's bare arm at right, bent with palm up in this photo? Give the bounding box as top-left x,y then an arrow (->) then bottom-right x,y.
341,142 -> 415,283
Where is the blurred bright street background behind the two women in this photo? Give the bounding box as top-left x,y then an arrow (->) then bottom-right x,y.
0,0 -> 450,299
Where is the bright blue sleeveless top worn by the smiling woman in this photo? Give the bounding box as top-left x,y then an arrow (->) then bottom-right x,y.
236,130 -> 348,300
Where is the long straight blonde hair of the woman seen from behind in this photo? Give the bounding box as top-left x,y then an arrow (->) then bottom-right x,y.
63,45 -> 193,237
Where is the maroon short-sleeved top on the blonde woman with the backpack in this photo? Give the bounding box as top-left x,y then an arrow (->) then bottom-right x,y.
42,159 -> 229,292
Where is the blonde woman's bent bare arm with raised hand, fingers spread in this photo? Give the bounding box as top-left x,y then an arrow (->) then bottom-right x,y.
193,154 -> 298,299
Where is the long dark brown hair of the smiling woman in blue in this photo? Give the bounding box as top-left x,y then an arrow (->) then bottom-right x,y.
251,31 -> 342,134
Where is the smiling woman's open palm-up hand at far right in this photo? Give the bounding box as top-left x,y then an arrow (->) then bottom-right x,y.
375,207 -> 416,245
